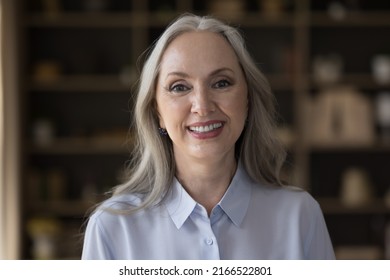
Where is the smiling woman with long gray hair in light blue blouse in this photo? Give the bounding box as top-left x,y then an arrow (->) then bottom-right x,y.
82,12 -> 334,259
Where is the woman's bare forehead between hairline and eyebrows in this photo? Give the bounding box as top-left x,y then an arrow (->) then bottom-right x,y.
161,31 -> 238,67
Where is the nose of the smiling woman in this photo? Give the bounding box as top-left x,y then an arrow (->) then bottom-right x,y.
191,86 -> 216,116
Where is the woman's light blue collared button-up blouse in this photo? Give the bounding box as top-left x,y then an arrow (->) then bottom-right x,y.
82,167 -> 335,260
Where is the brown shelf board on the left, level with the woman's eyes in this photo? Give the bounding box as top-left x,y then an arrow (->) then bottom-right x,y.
28,74 -> 131,92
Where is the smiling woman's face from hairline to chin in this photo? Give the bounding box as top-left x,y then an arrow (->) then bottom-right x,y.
156,31 -> 248,162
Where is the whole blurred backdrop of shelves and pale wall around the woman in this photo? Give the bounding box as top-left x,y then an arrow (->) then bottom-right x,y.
0,0 -> 390,259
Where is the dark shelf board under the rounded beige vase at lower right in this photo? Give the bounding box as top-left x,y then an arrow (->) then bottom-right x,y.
317,198 -> 390,215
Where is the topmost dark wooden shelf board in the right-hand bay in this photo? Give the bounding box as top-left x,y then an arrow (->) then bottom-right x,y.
310,11 -> 390,28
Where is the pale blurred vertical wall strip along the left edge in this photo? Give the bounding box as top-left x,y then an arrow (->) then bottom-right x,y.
0,0 -> 20,259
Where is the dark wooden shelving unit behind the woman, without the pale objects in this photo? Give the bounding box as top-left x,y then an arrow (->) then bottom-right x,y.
19,0 -> 390,259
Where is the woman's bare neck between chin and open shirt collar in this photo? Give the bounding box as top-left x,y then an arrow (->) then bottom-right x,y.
176,153 -> 237,214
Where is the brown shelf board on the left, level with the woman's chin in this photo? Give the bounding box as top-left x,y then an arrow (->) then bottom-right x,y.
30,138 -> 129,155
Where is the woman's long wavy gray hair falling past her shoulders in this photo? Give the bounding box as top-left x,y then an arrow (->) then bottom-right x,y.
113,14 -> 286,212
